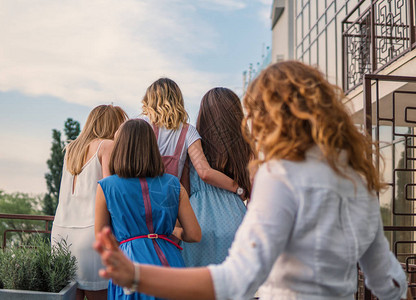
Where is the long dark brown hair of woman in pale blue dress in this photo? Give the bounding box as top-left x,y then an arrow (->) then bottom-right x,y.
196,87 -> 254,196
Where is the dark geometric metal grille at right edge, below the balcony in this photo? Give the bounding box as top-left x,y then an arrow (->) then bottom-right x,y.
362,74 -> 416,300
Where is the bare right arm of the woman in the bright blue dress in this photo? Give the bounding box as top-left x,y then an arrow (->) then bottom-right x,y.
174,185 -> 201,243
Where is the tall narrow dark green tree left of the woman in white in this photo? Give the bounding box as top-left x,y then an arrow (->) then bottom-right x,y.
42,118 -> 81,215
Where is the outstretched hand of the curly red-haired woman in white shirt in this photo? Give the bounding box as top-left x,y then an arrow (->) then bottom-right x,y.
94,227 -> 134,287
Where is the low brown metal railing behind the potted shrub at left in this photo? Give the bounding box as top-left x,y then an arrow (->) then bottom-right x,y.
0,214 -> 54,249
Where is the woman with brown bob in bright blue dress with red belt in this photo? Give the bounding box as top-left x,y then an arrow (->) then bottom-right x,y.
95,119 -> 201,299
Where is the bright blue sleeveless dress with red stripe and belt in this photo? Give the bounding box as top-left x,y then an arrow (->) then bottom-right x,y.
99,174 -> 185,299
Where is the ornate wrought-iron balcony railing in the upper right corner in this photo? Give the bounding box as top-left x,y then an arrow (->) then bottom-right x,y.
342,0 -> 416,92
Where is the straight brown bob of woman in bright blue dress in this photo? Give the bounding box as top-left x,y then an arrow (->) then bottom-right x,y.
109,119 -> 164,178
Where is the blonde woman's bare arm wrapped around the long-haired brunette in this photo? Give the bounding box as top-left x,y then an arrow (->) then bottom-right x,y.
188,140 -> 238,193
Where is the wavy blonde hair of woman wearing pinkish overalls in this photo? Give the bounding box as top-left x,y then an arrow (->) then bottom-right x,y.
142,78 -> 188,129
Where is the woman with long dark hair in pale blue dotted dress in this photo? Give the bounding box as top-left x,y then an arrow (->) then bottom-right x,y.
182,87 -> 253,267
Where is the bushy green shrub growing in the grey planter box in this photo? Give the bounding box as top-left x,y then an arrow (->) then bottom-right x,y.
0,236 -> 77,293
